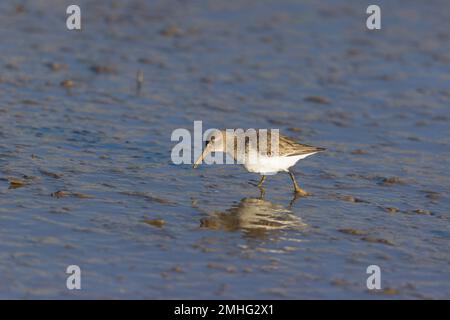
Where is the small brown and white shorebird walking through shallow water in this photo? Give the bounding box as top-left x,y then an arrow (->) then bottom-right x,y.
194,130 -> 325,196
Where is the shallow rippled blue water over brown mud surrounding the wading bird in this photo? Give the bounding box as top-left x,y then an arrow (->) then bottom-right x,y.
0,0 -> 450,299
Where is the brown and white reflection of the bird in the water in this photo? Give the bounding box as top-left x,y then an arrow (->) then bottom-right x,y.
196,193 -> 307,237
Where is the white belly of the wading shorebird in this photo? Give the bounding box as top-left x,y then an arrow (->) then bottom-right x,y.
244,152 -> 316,175
